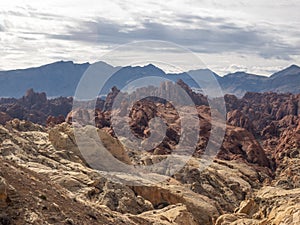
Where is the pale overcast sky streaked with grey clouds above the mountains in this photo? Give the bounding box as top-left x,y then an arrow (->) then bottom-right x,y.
0,0 -> 300,75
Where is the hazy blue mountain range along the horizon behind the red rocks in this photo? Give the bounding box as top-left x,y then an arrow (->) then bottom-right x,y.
0,61 -> 300,98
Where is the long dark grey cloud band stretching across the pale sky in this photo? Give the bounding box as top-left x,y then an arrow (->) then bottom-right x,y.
47,15 -> 298,60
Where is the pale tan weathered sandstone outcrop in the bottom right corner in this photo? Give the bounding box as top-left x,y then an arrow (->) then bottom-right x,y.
216,187 -> 300,225
